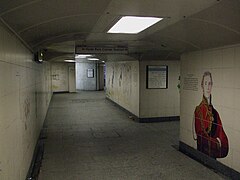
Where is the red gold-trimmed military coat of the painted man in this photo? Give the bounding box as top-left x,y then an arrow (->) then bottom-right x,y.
194,97 -> 228,158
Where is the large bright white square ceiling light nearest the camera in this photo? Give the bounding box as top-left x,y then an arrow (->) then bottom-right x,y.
108,16 -> 163,34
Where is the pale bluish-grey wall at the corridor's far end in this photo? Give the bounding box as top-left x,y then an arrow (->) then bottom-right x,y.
76,62 -> 97,90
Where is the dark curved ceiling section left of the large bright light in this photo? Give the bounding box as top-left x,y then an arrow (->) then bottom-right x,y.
1,0 -> 110,47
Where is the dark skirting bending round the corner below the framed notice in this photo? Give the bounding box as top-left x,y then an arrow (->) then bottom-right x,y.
106,97 -> 180,123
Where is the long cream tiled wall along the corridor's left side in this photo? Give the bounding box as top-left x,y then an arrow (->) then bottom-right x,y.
0,25 -> 52,180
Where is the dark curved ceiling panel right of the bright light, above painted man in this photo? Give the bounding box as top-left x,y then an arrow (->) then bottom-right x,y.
149,19 -> 240,52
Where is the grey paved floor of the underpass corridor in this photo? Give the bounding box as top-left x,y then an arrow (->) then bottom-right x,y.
39,92 -> 226,180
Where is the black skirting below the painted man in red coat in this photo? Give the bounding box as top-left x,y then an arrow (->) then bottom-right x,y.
179,141 -> 240,180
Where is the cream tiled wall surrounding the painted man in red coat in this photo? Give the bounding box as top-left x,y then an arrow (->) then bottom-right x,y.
180,45 -> 240,172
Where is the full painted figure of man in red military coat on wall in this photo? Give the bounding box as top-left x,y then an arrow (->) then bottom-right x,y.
193,72 -> 229,159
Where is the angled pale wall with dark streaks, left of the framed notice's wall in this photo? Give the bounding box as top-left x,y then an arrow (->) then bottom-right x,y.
106,61 -> 139,117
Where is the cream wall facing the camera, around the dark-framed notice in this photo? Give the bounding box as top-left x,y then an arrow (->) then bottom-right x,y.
140,61 -> 180,118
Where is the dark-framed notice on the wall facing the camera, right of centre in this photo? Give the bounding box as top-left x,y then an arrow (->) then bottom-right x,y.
147,66 -> 168,89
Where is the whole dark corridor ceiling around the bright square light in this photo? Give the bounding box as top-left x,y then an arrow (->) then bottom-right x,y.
0,0 -> 240,61
